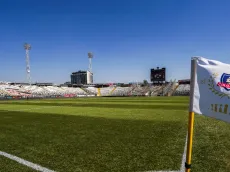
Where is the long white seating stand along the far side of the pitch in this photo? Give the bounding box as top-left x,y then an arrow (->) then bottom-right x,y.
0,81 -> 190,99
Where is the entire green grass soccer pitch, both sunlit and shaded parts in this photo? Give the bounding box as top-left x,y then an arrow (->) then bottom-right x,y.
0,97 -> 230,172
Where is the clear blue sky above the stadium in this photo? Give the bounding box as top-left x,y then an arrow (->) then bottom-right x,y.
0,0 -> 230,83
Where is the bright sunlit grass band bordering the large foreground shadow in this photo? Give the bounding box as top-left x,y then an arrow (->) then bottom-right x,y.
1,105 -> 187,121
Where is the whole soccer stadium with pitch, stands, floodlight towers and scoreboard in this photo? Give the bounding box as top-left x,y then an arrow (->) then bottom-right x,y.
0,44 -> 230,172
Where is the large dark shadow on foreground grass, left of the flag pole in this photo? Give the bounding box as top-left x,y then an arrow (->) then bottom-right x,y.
0,111 -> 186,172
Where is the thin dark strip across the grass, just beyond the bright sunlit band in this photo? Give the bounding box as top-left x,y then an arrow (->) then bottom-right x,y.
0,101 -> 188,110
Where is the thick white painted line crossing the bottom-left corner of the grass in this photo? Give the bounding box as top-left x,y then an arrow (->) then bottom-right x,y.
0,151 -> 55,172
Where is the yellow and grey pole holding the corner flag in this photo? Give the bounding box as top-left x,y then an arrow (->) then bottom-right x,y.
185,58 -> 196,172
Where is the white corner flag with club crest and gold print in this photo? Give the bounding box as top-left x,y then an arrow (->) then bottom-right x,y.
190,57 -> 230,123
